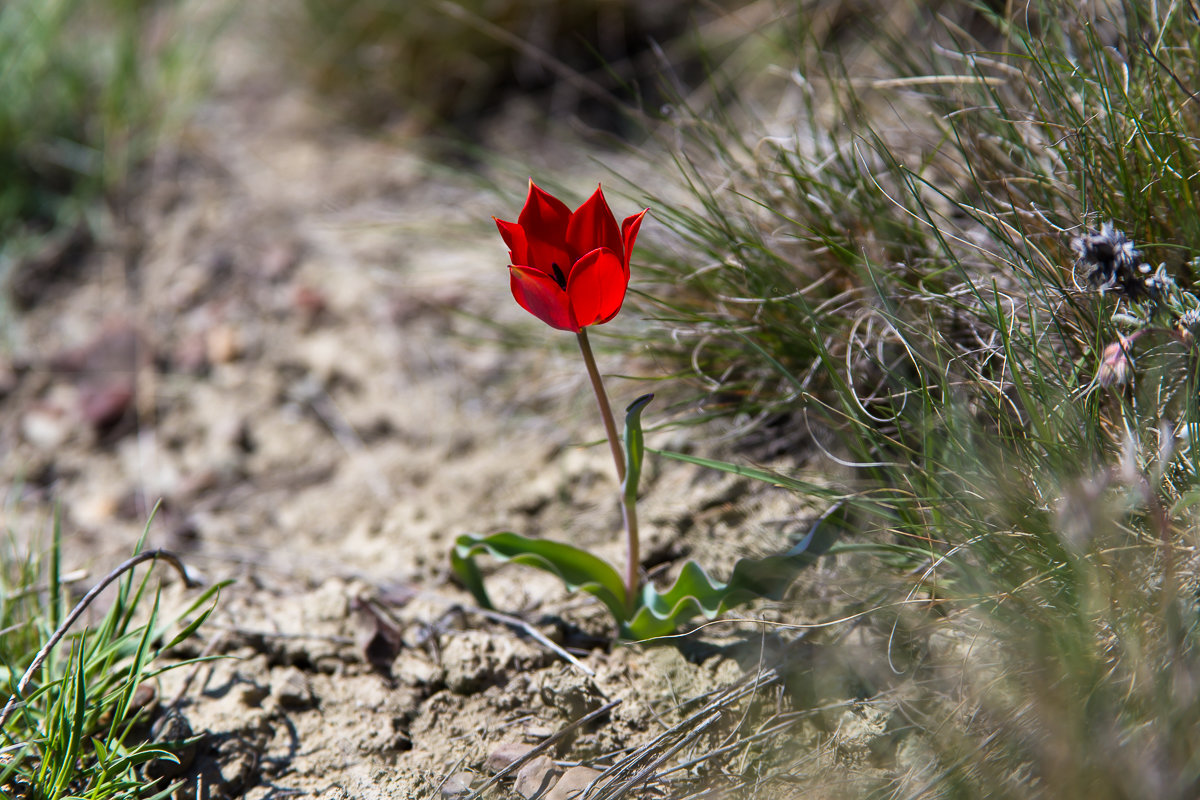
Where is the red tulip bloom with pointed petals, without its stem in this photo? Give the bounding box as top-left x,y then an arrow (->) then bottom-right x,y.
493,180 -> 649,333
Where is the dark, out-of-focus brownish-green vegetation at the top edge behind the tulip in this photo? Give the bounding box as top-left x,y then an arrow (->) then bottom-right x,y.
283,0 -> 744,136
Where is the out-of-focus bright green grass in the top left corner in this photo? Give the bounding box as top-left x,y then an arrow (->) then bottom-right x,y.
0,0 -> 206,239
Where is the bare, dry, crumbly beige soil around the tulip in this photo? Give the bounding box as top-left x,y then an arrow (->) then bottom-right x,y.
0,29 -> 844,800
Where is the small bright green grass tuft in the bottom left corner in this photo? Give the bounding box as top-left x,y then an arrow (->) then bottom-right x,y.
0,513 -> 221,800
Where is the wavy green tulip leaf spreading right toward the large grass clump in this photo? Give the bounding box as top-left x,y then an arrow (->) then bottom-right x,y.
622,505 -> 845,639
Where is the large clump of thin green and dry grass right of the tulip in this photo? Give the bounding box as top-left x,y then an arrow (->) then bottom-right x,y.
642,2 -> 1200,799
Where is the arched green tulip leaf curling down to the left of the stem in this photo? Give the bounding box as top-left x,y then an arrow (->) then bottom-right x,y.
450,531 -> 625,622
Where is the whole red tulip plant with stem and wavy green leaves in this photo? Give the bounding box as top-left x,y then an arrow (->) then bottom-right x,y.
450,180 -> 825,638
